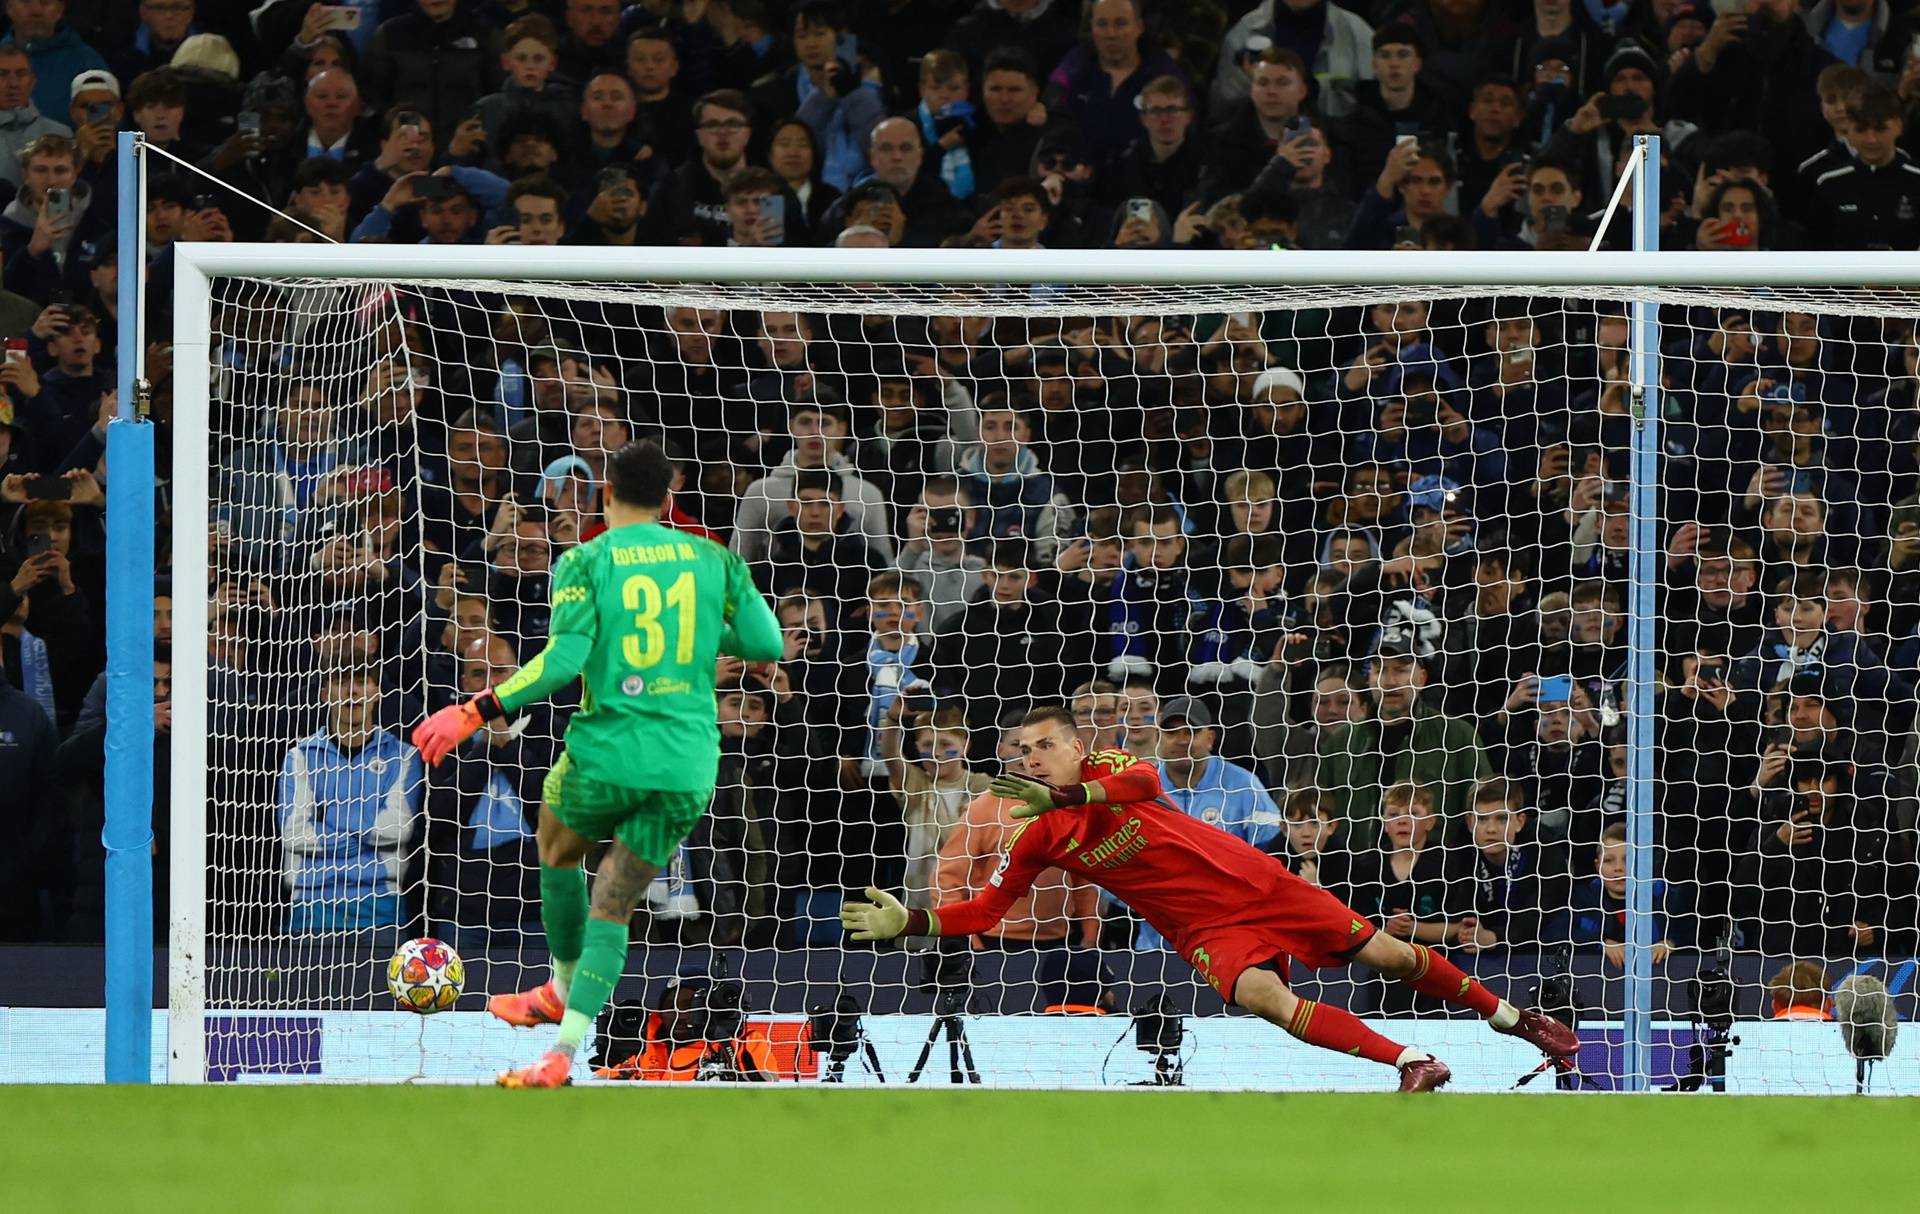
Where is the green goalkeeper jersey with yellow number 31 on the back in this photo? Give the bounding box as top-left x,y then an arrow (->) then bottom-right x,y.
495,522 -> 781,789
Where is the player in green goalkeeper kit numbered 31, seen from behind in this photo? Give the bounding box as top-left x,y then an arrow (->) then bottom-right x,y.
413,442 -> 781,1087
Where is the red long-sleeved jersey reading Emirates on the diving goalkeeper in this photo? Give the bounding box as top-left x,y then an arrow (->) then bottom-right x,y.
937,751 -> 1319,955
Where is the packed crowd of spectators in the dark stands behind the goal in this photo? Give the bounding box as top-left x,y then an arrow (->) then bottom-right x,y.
0,0 -> 1920,998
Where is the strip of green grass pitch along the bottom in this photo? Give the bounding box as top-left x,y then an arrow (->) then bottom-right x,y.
0,1087 -> 1920,1214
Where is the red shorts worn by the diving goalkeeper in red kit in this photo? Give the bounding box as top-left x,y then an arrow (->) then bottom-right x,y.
1177,874 -> 1375,1003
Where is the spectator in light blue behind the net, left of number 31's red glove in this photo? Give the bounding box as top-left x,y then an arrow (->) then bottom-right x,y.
278,665 -> 422,939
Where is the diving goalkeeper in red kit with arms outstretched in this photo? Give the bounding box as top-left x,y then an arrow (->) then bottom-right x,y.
841,709 -> 1580,1091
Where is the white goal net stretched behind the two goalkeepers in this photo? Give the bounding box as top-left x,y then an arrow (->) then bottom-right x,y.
175,254 -> 1920,1091
